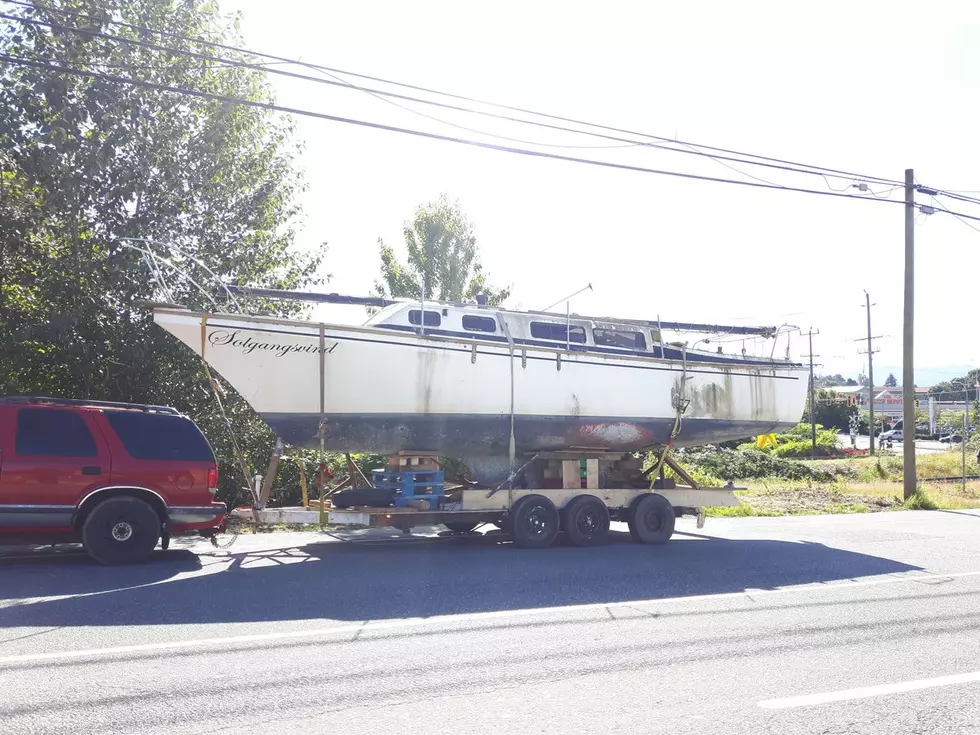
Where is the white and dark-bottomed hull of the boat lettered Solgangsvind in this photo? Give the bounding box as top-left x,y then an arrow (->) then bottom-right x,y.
154,309 -> 807,466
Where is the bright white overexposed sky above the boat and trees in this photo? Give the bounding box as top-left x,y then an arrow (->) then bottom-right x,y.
221,0 -> 980,385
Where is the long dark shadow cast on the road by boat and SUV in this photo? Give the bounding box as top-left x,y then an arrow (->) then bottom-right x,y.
0,533 -> 919,627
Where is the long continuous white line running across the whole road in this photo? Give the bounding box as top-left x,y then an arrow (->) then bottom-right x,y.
0,570 -> 980,665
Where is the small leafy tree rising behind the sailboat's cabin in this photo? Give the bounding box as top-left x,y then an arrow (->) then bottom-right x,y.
374,194 -> 510,306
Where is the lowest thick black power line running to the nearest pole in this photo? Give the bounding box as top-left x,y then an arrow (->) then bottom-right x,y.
0,54 -> 920,210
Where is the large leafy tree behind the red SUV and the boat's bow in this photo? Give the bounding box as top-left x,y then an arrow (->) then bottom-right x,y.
0,0 -> 323,501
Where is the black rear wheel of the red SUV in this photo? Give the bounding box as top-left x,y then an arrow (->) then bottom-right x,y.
82,497 -> 160,564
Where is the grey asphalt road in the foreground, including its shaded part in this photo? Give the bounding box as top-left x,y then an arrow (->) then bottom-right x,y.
0,511 -> 980,735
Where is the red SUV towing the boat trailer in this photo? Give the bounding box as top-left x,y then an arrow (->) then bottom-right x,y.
0,397 -> 227,564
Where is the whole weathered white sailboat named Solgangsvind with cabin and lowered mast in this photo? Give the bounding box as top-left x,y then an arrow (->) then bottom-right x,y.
153,289 -> 807,481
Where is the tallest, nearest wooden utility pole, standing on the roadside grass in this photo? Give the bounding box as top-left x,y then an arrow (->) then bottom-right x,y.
902,168 -> 920,500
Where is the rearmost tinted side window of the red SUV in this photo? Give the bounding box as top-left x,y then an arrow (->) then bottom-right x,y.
105,411 -> 214,462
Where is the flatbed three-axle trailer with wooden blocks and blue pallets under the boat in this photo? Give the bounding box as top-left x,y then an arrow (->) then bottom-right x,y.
232,452 -> 740,548
